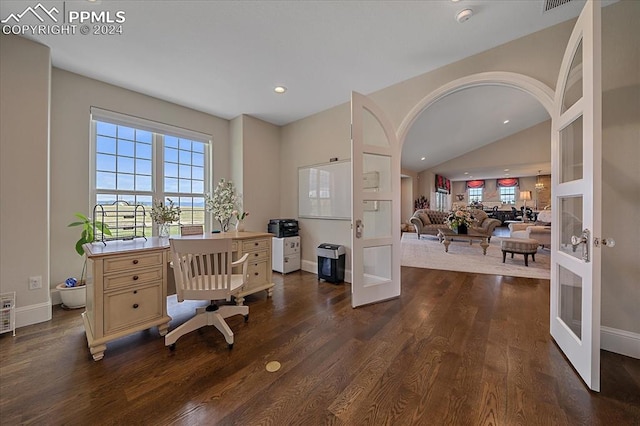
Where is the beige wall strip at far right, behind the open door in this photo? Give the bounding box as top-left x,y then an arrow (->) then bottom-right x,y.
602,1 -> 640,332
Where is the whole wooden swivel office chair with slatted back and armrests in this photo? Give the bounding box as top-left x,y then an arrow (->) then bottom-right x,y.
164,238 -> 249,350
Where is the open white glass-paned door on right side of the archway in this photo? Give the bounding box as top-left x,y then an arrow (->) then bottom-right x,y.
550,0 -> 602,391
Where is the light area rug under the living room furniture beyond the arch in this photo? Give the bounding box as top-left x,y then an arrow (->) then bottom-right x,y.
401,232 -> 551,280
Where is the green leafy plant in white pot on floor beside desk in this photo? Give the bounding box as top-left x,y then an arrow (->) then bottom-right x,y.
56,213 -> 111,309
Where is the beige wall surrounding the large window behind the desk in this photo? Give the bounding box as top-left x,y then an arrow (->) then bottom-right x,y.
50,68 -> 230,287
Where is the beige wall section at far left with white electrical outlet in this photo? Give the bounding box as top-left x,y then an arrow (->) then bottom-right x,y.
0,35 -> 51,326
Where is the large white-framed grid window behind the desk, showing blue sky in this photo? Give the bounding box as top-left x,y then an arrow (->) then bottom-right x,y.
91,108 -> 211,236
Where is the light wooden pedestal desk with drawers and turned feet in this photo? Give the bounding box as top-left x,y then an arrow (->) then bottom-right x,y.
82,231 -> 273,361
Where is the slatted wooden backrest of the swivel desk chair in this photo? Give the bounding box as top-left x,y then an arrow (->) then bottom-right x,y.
169,238 -> 238,301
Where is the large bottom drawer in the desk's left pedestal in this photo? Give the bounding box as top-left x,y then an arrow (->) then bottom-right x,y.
104,284 -> 163,334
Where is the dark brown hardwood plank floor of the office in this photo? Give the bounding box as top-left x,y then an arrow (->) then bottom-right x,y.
0,268 -> 640,425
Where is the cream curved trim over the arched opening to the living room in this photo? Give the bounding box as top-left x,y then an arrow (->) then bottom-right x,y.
397,71 -> 554,147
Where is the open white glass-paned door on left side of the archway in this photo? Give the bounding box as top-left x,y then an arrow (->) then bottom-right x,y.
351,92 -> 401,308
